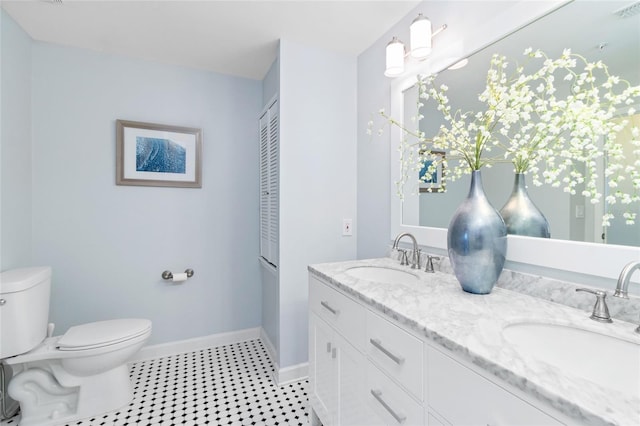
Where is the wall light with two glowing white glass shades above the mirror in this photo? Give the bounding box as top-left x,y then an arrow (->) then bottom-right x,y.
384,13 -> 447,77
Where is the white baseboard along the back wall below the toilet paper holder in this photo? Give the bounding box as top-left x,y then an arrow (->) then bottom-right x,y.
130,327 -> 261,362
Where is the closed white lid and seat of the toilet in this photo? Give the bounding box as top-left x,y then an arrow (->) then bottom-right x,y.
56,318 -> 151,351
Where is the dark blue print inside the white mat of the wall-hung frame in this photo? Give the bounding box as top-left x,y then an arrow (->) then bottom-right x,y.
136,136 -> 187,174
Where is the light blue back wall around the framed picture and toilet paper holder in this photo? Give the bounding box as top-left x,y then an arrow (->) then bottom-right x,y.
32,43 -> 262,343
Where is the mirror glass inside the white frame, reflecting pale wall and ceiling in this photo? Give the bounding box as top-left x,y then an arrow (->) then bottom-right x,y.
402,1 -> 640,246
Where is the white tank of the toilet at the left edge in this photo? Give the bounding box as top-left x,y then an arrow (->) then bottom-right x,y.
0,267 -> 51,359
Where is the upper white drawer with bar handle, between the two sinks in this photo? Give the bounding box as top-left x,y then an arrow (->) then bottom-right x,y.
365,311 -> 424,401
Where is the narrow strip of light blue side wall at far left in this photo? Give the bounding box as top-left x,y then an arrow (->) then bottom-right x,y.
0,9 -> 32,271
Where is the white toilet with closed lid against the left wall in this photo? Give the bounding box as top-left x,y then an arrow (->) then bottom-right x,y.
0,267 -> 151,426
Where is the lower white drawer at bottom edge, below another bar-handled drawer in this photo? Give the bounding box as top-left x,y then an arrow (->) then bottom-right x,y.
366,361 -> 424,426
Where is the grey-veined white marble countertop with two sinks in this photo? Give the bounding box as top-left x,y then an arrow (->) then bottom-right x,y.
309,258 -> 640,426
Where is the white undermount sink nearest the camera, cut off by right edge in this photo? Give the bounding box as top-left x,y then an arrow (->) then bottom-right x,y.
503,322 -> 640,398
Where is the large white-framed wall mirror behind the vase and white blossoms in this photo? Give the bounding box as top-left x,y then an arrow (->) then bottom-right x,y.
391,0 -> 640,287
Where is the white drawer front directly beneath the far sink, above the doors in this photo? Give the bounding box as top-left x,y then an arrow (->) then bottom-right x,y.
309,276 -> 365,349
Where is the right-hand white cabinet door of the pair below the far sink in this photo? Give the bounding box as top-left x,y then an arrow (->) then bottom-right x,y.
334,332 -> 371,426
